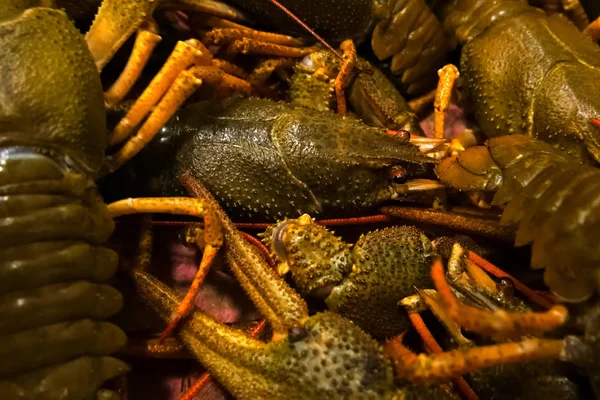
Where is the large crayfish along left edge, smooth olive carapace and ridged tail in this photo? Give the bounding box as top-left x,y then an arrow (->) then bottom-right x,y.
0,2 -> 128,400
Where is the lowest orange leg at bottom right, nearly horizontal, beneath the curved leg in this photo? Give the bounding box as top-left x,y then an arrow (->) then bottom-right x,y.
384,337 -> 563,384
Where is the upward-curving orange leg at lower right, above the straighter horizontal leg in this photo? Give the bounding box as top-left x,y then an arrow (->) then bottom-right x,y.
431,258 -> 568,338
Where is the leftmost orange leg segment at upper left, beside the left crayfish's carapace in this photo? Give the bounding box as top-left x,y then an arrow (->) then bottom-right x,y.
104,20 -> 161,107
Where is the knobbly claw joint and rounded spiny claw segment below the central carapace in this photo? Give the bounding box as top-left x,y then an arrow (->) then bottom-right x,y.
263,215 -> 434,338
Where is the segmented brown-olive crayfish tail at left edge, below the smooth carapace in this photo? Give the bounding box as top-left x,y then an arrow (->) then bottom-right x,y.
0,147 -> 128,399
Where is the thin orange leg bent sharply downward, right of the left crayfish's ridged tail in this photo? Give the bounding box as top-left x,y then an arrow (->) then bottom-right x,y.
108,197 -> 223,343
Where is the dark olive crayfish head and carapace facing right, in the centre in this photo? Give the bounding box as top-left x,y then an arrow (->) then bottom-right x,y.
131,99 -> 441,221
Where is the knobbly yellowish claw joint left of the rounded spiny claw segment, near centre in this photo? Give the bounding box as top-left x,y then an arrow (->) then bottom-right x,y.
263,214 -> 352,298
